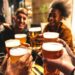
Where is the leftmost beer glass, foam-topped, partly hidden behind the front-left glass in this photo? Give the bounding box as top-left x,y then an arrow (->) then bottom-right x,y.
5,39 -> 21,54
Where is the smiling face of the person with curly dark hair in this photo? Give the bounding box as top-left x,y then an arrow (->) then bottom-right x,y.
49,9 -> 61,26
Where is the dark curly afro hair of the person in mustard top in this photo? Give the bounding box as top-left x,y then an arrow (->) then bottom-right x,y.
52,2 -> 69,18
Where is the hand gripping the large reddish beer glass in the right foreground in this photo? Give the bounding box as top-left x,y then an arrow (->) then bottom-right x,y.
44,58 -> 75,75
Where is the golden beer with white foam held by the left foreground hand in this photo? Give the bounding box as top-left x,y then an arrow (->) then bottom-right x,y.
10,47 -> 28,63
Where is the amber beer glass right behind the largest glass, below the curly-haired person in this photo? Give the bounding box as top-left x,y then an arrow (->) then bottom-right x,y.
43,32 -> 59,42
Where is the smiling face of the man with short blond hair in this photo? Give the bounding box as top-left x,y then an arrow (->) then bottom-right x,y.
16,13 -> 27,30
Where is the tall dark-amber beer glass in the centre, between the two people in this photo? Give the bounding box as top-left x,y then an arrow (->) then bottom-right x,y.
29,27 -> 41,50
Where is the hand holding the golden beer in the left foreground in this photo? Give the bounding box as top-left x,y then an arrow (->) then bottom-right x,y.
1,54 -> 32,75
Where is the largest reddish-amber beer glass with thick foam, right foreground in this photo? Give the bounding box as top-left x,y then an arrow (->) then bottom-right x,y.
42,42 -> 63,75
